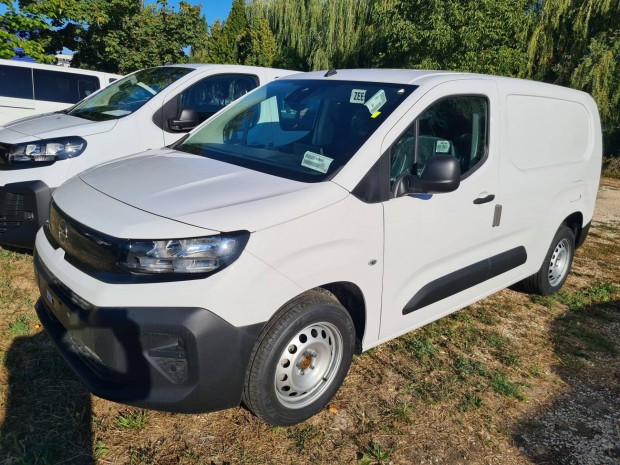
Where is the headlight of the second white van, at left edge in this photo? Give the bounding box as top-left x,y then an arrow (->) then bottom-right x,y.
2,137 -> 86,163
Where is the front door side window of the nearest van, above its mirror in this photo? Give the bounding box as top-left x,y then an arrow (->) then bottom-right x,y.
390,96 -> 488,183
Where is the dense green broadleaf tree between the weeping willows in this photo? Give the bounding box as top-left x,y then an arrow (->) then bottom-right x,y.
374,0 -> 537,76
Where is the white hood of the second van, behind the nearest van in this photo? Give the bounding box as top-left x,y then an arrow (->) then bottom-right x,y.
0,113 -> 117,144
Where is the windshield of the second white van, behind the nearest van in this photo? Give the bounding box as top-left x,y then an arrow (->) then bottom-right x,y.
68,66 -> 194,121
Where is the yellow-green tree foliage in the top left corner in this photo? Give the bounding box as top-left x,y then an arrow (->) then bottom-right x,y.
0,0 -> 54,62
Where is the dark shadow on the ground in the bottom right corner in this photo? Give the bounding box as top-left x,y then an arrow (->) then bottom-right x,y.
513,300 -> 620,465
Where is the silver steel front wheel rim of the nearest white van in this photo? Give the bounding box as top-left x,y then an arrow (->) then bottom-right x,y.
274,322 -> 343,409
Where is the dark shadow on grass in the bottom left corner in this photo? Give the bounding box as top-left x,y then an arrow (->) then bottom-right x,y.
0,332 -> 94,465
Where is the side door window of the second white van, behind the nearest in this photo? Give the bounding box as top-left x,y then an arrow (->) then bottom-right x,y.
179,75 -> 258,123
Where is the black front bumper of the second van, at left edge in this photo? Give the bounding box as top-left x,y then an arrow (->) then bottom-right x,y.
0,181 -> 52,249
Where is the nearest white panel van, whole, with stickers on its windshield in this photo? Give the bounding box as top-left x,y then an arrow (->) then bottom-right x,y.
35,70 -> 601,425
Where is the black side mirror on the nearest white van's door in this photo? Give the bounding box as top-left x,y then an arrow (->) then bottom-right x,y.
394,155 -> 461,197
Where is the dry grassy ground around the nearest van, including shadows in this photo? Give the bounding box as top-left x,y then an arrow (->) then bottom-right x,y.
0,179 -> 620,465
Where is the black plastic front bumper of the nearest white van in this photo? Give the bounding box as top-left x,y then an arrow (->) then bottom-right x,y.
34,254 -> 264,413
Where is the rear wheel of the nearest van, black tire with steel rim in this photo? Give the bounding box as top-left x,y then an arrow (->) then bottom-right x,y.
523,224 -> 575,295
